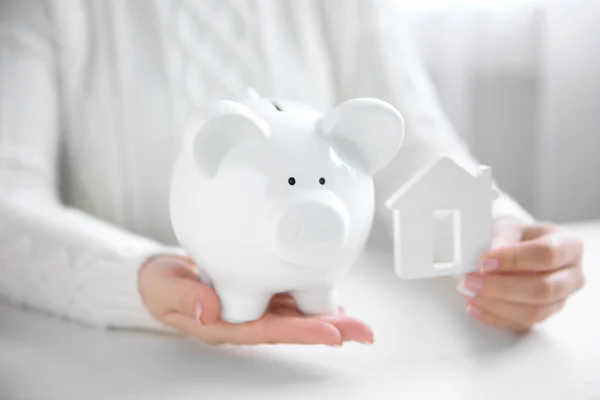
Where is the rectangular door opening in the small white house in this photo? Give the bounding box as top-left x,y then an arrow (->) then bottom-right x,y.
432,210 -> 461,269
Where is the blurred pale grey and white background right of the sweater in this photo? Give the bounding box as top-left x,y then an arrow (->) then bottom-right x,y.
397,0 -> 600,222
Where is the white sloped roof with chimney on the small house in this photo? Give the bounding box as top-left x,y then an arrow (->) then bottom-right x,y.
386,156 -> 498,208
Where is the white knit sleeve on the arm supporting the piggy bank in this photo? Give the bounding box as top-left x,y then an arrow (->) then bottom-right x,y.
0,0 -> 178,330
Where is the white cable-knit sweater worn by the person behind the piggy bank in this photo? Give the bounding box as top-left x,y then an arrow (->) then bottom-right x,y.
0,0 -> 527,328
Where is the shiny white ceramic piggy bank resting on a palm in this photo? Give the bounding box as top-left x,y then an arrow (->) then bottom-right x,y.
170,92 -> 404,323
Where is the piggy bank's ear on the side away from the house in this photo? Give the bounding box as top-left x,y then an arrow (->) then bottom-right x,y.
185,101 -> 268,178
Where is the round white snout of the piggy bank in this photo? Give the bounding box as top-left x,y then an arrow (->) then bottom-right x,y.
275,201 -> 348,265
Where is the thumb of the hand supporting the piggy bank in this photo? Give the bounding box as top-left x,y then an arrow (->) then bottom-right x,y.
150,276 -> 221,324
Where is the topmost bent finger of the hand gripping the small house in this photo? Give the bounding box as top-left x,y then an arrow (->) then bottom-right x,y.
479,232 -> 583,272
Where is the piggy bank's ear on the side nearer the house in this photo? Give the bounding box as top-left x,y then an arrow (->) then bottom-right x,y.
317,99 -> 404,175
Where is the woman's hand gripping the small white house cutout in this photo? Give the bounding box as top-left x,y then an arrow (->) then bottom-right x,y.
458,219 -> 584,332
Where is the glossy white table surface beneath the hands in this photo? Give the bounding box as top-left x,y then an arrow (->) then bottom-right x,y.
0,224 -> 600,400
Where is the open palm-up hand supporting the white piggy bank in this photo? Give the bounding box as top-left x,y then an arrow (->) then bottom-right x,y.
138,256 -> 373,346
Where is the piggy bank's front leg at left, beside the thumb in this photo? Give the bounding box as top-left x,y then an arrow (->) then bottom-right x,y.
215,287 -> 271,324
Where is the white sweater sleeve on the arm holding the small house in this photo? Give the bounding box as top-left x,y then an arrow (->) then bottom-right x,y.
322,0 -> 533,236
